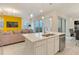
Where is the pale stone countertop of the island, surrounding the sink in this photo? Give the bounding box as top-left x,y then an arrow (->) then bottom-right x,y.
22,32 -> 64,42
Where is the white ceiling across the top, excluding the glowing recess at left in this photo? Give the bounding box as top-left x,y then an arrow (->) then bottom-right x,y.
0,3 -> 79,17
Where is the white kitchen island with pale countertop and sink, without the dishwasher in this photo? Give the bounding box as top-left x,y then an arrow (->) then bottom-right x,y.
22,32 -> 65,55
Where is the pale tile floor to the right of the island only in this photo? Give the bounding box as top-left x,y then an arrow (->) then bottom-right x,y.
57,37 -> 79,55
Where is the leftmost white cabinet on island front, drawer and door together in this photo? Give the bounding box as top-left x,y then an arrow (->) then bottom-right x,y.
34,40 -> 47,55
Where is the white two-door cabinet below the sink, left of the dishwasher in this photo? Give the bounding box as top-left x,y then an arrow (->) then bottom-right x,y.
47,36 -> 59,55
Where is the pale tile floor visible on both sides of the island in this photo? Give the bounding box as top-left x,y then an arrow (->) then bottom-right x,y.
0,38 -> 79,55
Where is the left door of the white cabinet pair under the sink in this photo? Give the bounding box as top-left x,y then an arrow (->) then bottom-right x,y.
47,38 -> 55,55
